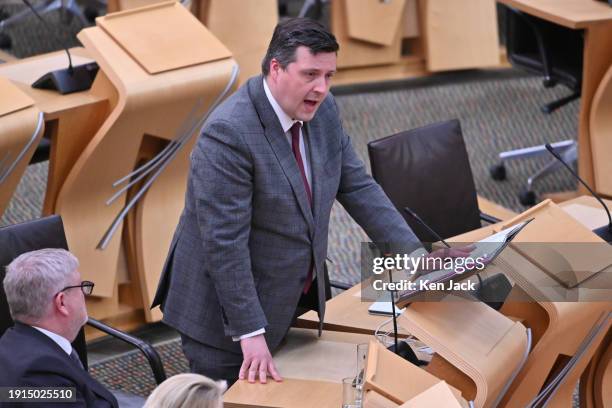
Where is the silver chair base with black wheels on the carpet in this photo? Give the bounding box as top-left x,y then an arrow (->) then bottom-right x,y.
489,140 -> 578,206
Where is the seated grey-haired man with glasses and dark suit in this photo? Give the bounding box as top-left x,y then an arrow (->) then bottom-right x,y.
0,249 -> 118,407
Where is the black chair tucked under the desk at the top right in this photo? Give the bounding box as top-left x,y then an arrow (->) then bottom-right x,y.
506,7 -> 584,113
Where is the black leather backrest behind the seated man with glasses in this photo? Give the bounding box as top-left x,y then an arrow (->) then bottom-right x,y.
0,215 -> 87,368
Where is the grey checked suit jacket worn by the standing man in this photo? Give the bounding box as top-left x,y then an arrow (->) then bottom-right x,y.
153,76 -> 420,352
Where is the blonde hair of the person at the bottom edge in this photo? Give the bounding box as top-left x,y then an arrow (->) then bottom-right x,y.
143,374 -> 227,408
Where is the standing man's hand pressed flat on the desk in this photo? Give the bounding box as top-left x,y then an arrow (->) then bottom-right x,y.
238,334 -> 283,384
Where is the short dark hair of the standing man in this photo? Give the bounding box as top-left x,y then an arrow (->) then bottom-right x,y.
261,18 -> 339,76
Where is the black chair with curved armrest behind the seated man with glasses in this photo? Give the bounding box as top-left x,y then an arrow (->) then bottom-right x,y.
0,215 -> 166,384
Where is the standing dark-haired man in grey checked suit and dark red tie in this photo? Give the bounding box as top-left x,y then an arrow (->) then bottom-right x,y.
153,19 -> 460,382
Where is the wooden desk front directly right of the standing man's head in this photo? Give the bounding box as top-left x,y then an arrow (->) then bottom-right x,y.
330,0 -> 506,85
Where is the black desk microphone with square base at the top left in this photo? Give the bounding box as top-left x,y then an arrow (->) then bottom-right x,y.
22,0 -> 99,95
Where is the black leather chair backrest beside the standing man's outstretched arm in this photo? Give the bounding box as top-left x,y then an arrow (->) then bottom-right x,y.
368,120 -> 481,242
